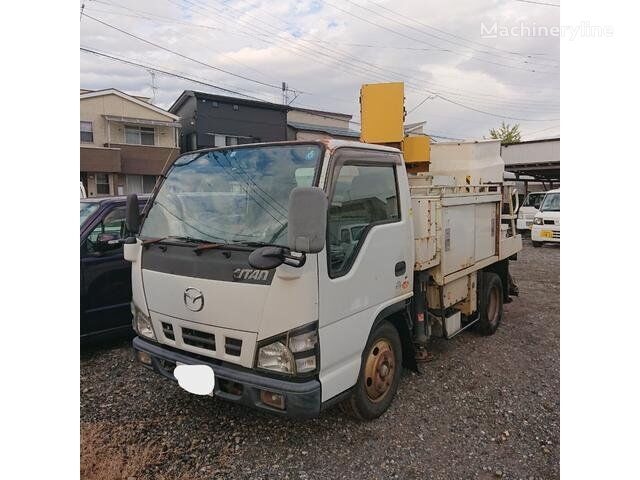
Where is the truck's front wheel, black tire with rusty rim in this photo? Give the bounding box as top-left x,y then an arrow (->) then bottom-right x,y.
341,321 -> 402,420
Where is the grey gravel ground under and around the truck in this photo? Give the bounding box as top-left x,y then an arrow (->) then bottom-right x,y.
80,240 -> 560,480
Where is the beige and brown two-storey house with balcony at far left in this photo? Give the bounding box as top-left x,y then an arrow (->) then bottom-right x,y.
80,88 -> 180,197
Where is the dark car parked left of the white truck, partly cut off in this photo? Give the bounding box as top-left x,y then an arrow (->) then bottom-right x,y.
80,195 -> 150,340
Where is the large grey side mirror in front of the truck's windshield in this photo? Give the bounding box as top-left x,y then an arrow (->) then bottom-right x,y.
288,187 -> 328,253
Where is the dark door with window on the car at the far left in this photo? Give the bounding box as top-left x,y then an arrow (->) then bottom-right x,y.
80,205 -> 131,336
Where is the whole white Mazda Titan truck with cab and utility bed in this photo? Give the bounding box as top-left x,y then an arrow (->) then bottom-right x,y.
125,136 -> 522,419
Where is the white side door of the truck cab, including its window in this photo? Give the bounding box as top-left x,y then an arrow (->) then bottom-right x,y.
318,147 -> 414,401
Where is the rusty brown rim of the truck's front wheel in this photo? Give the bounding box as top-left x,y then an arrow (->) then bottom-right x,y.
364,338 -> 396,403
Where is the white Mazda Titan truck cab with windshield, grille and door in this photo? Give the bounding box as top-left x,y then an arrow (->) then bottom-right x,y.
125,141 -> 414,417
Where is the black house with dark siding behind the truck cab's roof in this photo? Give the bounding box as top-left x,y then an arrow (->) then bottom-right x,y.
169,90 -> 288,152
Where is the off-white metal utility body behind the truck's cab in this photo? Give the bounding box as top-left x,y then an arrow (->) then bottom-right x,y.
409,142 -> 522,326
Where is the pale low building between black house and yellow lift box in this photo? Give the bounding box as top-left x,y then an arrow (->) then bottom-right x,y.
287,107 -> 360,140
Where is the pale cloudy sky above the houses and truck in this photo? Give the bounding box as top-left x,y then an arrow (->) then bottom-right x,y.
80,0 -> 560,140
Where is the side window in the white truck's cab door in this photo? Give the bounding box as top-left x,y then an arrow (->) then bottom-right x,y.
327,165 -> 400,278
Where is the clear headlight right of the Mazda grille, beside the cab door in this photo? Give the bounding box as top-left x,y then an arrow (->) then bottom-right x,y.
256,322 -> 320,375
